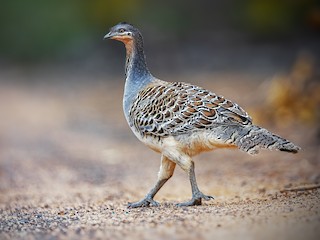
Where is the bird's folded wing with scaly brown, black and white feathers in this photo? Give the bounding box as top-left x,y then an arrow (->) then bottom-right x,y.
130,82 -> 251,136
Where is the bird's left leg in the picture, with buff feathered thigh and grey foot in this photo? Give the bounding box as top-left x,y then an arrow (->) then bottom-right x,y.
128,155 -> 176,208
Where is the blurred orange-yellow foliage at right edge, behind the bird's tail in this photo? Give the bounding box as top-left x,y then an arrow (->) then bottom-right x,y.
254,53 -> 320,126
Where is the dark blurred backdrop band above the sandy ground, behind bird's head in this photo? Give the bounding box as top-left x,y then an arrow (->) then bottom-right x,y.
0,0 -> 320,75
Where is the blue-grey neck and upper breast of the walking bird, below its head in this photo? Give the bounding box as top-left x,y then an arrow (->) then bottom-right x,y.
123,35 -> 154,121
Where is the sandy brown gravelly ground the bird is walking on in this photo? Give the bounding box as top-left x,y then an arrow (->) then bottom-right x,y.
0,68 -> 320,240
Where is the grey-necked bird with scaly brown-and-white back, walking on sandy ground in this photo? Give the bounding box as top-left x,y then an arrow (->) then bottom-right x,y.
104,22 -> 300,208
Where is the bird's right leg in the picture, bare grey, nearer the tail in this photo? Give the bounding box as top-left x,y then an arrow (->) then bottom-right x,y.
178,161 -> 214,207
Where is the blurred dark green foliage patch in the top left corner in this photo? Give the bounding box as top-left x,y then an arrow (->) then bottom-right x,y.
0,0 -> 88,58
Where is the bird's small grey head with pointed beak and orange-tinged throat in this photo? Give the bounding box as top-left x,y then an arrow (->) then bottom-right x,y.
103,22 -> 140,43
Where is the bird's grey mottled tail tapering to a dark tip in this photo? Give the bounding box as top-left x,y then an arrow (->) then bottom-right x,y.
234,125 -> 300,154
